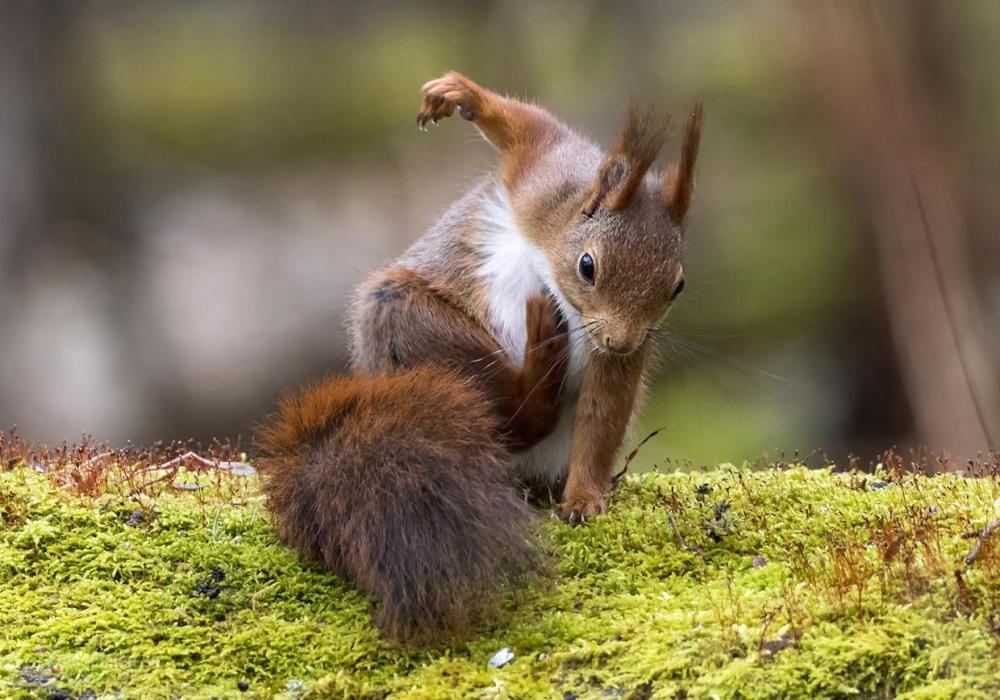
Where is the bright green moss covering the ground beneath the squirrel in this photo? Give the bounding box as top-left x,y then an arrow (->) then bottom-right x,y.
0,467 -> 1000,698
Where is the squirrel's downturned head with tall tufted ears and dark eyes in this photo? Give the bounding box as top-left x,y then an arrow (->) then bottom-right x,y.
548,102 -> 702,355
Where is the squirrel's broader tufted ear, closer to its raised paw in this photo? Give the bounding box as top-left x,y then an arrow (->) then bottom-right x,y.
583,100 -> 666,216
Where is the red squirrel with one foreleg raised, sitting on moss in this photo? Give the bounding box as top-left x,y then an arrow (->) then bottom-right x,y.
258,72 -> 702,641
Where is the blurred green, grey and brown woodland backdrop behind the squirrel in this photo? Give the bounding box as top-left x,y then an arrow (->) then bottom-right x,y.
0,0 -> 1000,463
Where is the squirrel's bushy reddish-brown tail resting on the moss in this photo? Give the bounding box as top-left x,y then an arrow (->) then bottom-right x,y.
258,367 -> 542,642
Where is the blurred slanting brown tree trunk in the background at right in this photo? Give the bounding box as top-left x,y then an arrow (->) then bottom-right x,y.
793,3 -> 1000,458
